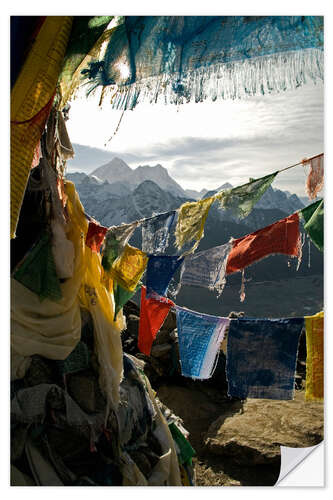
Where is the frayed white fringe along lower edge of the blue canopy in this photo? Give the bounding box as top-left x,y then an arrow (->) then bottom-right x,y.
101,48 -> 324,109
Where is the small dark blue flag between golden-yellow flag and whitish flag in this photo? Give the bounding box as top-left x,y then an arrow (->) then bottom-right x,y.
146,255 -> 184,297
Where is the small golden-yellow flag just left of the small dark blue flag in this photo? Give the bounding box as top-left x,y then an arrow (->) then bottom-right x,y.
109,245 -> 148,292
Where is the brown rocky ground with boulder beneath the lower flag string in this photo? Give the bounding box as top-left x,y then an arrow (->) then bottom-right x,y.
123,302 -> 324,486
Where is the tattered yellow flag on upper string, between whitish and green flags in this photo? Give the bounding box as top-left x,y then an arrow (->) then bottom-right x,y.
175,196 -> 215,252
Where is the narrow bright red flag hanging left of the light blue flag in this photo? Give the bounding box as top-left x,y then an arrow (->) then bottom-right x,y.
138,286 -> 175,356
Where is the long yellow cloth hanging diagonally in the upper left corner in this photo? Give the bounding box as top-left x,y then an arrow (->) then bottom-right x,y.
10,16 -> 72,238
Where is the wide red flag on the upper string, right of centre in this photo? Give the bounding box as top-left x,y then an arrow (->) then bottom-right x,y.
227,213 -> 301,274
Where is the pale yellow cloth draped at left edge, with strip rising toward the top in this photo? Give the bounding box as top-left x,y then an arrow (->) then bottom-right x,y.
11,181 -> 88,380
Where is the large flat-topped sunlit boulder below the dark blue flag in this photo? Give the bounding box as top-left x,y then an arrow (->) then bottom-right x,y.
205,391 -> 324,465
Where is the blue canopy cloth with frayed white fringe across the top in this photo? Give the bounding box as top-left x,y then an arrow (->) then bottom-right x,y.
75,16 -> 323,109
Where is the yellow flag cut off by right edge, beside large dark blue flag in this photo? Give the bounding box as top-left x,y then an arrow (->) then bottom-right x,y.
305,311 -> 324,401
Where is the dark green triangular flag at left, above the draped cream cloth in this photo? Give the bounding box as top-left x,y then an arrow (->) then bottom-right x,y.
13,232 -> 62,301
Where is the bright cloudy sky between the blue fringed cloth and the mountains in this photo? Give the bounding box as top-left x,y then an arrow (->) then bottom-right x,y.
67,83 -> 324,196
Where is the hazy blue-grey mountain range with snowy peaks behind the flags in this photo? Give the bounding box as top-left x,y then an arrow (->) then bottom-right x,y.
67,154 -> 323,314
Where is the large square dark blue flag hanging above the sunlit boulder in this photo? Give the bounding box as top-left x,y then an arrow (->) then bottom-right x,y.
226,318 -> 304,400
